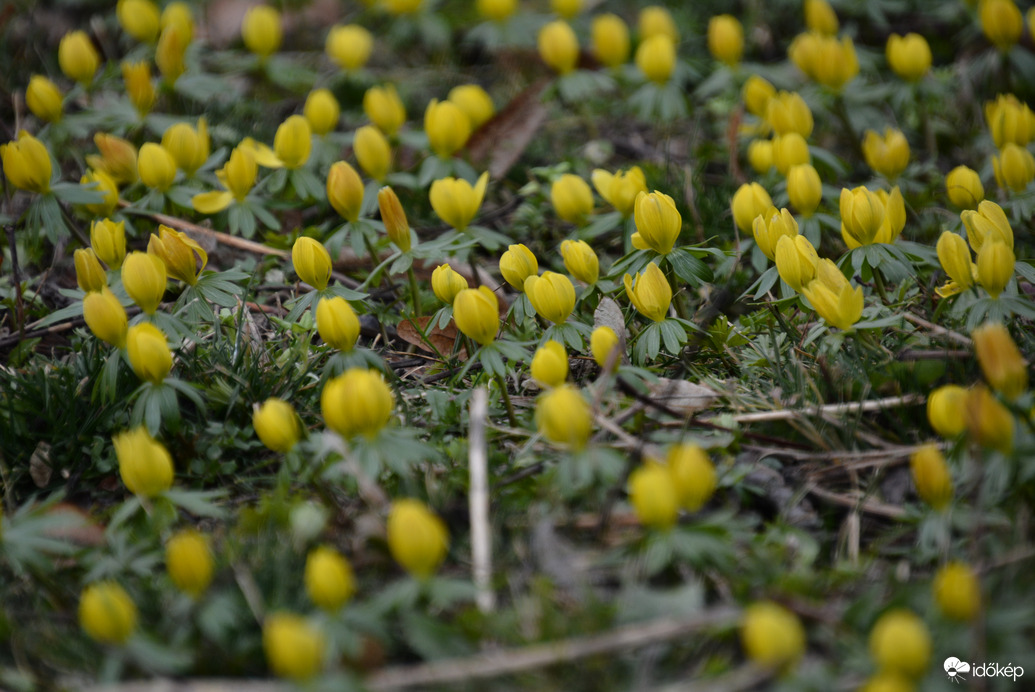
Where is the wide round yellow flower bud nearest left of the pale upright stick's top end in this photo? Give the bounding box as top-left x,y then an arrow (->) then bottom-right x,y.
320,366 -> 394,438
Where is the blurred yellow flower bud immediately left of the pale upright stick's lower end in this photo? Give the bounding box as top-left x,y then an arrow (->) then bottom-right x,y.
387,499 -> 449,579
